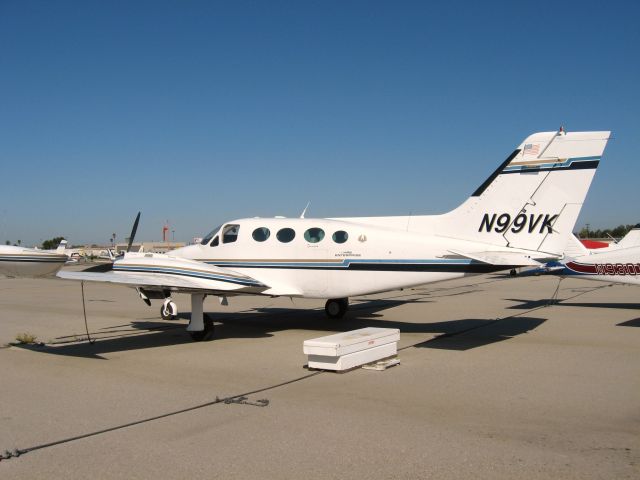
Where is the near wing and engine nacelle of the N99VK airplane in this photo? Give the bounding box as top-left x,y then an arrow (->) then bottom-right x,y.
58,254 -> 269,294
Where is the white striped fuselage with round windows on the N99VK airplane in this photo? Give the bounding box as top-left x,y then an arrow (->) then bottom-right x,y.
169,217 -> 511,298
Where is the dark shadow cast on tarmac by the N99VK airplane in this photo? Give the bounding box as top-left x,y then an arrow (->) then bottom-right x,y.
13,299 -> 545,359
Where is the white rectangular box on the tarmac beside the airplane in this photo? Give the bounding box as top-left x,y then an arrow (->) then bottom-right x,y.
303,327 -> 400,370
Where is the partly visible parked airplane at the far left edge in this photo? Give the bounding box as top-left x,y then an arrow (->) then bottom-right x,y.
0,240 -> 69,277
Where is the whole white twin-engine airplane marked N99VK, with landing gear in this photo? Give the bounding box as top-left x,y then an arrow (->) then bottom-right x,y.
58,129 -> 610,340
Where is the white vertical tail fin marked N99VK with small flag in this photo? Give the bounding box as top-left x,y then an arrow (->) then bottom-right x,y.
436,129 -> 610,255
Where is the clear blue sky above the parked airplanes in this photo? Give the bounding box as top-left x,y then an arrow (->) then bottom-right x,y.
0,0 -> 640,244
